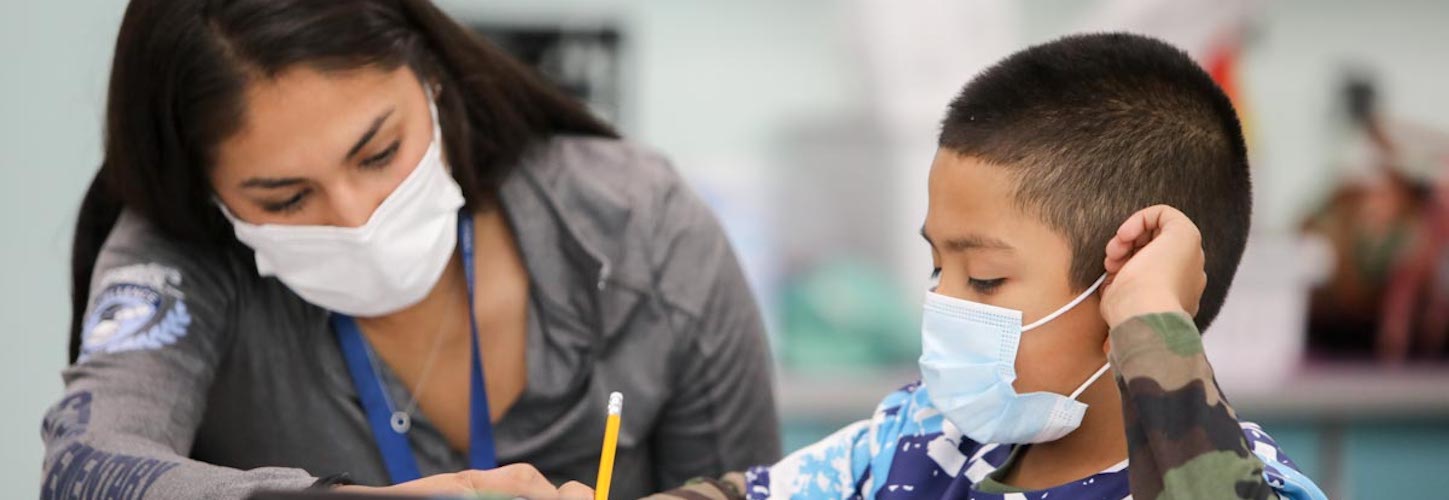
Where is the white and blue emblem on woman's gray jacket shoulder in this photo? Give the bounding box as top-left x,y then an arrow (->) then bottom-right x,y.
80,264 -> 191,361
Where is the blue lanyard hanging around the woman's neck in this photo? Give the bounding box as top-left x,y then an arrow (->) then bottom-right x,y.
332,209 -> 498,484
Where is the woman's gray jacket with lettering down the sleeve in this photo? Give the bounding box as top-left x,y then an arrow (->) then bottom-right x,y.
42,136 -> 780,499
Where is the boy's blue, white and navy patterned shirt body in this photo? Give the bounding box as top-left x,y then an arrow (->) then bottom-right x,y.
745,383 -> 1326,500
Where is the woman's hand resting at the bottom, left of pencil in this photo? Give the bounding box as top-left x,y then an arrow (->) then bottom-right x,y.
338,464 -> 594,500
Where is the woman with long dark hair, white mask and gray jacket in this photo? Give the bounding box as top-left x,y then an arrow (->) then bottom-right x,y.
42,0 -> 780,499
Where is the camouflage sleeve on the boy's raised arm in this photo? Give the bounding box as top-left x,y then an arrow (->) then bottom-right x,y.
1108,313 -> 1278,499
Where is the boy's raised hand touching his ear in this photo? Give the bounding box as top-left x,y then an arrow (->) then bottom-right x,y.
1101,204 -> 1207,328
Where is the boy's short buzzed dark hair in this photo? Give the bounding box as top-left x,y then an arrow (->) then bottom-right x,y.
939,33 -> 1252,329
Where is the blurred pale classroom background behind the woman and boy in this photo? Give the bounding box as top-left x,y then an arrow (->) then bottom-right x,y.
0,0 -> 1449,499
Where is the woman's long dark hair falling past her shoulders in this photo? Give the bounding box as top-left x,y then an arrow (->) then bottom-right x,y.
70,0 -> 617,361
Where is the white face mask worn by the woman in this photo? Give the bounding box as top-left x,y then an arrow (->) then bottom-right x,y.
217,96 -> 464,317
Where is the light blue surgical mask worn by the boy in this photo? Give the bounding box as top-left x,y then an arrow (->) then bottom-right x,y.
920,275 -> 1108,443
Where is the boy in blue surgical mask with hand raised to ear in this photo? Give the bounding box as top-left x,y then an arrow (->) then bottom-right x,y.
654,33 -> 1324,500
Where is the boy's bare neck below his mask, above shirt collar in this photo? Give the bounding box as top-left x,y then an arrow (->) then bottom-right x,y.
1001,371 -> 1127,490
